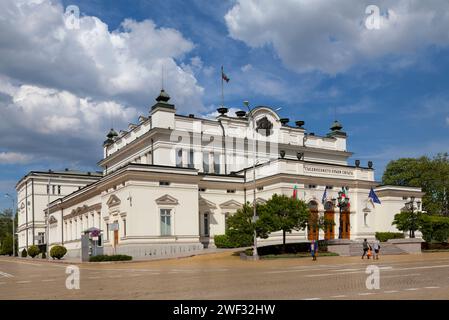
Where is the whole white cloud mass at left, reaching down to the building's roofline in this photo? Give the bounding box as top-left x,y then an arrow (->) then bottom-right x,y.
0,0 -> 205,167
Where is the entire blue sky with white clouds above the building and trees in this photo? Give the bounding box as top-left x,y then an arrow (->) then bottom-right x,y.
0,0 -> 449,208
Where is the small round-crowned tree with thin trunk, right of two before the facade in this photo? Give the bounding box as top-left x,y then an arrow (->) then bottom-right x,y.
262,194 -> 310,250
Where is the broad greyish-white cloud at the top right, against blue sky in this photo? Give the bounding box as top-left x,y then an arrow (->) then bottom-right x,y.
225,0 -> 449,74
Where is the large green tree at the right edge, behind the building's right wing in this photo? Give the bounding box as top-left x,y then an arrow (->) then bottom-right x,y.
382,153 -> 449,216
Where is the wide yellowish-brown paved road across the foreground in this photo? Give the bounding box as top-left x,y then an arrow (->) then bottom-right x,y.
0,252 -> 449,300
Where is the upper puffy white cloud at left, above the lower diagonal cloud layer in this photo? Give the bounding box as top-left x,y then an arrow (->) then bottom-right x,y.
0,0 -> 203,111
